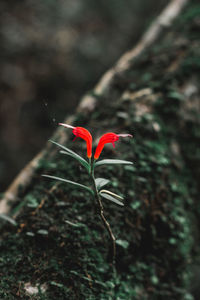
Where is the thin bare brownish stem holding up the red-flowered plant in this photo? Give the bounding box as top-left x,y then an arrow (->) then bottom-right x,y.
90,166 -> 116,267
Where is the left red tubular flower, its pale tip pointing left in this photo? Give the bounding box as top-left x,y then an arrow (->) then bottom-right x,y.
58,123 -> 92,158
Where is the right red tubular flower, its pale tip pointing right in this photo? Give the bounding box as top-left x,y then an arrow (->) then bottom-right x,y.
94,132 -> 133,159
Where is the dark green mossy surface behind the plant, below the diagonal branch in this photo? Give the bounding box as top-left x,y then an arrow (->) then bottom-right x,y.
0,4 -> 200,300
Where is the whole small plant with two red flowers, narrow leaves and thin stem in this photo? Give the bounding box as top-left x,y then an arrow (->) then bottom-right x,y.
43,123 -> 133,264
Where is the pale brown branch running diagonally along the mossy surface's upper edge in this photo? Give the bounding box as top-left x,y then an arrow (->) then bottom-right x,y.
0,0 -> 189,214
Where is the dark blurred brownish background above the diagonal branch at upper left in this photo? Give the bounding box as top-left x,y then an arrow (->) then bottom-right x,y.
0,0 -> 168,192
